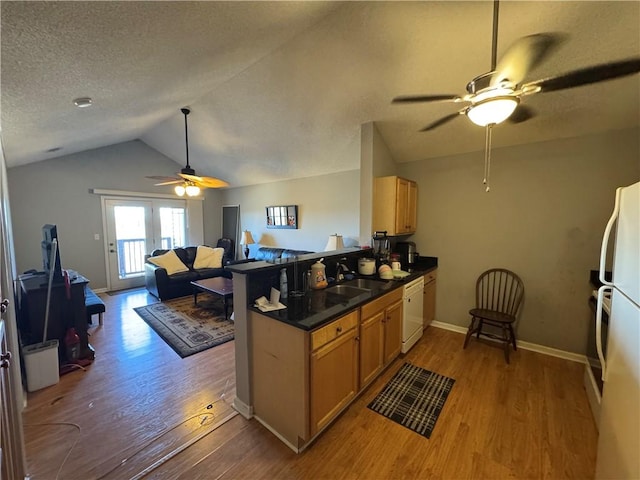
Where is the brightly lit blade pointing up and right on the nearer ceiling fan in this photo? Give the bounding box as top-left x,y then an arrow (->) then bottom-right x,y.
491,33 -> 560,85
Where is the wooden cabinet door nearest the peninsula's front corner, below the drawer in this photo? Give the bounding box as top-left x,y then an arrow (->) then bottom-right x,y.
310,328 -> 358,435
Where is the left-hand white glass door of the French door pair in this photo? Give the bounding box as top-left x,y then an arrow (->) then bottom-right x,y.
105,199 -> 154,290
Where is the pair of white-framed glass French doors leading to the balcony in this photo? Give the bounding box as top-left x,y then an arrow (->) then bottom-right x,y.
104,199 -> 187,290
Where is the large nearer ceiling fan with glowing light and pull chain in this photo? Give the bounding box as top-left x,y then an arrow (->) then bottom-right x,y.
393,0 -> 640,192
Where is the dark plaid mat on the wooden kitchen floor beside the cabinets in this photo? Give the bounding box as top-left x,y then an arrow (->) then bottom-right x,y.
368,363 -> 455,438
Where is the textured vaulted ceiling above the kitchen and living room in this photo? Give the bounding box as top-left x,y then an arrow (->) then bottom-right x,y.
0,1 -> 640,186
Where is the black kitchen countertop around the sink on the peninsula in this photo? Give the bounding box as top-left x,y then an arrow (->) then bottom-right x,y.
249,257 -> 438,330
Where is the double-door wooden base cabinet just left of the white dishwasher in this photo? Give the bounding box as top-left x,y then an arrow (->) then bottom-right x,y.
360,289 -> 402,388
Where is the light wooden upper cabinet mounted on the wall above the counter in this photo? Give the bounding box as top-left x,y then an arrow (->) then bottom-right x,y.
372,176 -> 418,235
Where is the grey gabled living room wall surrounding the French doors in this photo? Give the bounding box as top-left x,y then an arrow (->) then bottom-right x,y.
8,141 -> 220,288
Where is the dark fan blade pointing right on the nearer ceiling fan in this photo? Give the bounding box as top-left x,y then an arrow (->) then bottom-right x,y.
522,58 -> 640,92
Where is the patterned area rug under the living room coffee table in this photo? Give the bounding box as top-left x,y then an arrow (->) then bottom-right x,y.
134,296 -> 234,358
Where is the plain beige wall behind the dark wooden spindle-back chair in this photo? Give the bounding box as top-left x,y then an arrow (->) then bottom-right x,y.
399,129 -> 640,353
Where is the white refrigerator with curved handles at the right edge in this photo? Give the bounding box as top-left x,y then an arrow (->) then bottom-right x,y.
596,183 -> 640,479
